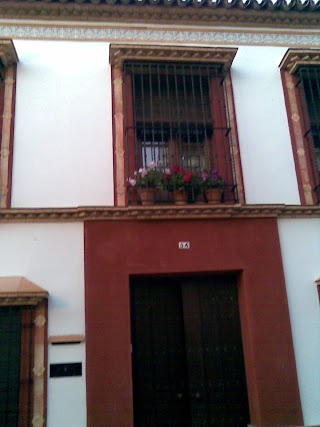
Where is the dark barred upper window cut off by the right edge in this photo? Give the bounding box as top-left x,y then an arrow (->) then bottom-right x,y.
297,67 -> 320,203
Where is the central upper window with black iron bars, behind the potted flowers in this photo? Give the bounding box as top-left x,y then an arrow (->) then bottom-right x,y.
124,61 -> 238,203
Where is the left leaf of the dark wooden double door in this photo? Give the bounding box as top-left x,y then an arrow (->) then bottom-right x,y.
131,280 -> 190,427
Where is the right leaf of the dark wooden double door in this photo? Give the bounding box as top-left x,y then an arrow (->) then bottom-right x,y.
184,276 -> 249,427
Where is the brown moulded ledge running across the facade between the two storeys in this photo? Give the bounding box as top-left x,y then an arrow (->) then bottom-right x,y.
0,204 -> 320,223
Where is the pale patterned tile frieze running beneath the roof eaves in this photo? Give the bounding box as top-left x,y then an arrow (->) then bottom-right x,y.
0,24 -> 320,47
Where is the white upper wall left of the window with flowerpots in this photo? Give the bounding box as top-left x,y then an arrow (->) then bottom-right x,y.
12,40 -> 113,207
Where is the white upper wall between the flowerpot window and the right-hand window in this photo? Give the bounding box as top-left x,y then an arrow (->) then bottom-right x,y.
231,46 -> 300,204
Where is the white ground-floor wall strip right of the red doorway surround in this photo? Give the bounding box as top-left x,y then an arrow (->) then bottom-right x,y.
278,219 -> 320,425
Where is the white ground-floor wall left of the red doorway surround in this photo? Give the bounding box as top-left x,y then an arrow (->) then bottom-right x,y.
0,223 -> 86,427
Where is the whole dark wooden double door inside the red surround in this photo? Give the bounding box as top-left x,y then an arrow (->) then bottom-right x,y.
130,275 -> 250,427
